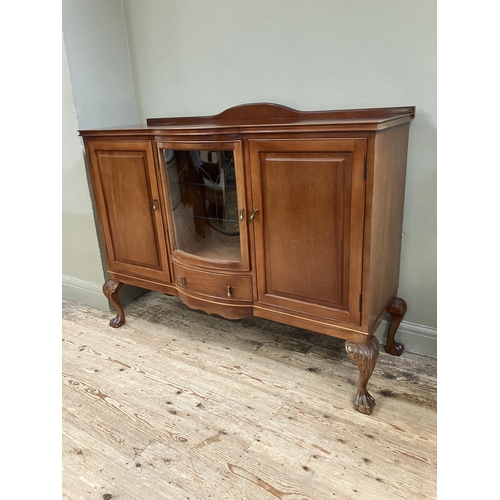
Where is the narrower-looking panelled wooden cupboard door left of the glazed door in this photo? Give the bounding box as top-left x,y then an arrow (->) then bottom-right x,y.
87,140 -> 170,282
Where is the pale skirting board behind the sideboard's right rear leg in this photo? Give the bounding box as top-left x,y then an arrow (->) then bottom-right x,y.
375,319 -> 437,358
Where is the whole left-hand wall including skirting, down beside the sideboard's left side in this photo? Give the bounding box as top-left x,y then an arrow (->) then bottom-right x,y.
62,0 -> 142,309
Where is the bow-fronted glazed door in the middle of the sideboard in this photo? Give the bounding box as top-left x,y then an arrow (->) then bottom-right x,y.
157,141 -> 249,270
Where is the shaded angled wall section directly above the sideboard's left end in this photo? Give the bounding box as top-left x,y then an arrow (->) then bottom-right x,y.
62,0 -> 138,129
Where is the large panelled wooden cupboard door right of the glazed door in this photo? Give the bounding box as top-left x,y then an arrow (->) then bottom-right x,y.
249,139 -> 365,325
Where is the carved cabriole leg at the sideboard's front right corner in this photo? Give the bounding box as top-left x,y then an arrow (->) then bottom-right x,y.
345,337 -> 379,415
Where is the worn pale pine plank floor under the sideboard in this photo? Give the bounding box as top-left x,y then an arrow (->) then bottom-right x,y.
62,292 -> 437,500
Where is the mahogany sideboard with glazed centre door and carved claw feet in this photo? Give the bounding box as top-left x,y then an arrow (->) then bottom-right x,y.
79,103 -> 415,414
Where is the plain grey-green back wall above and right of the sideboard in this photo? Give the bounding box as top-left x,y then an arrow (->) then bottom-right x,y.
124,0 -> 437,328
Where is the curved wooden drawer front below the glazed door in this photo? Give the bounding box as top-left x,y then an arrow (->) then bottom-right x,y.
173,263 -> 252,302
